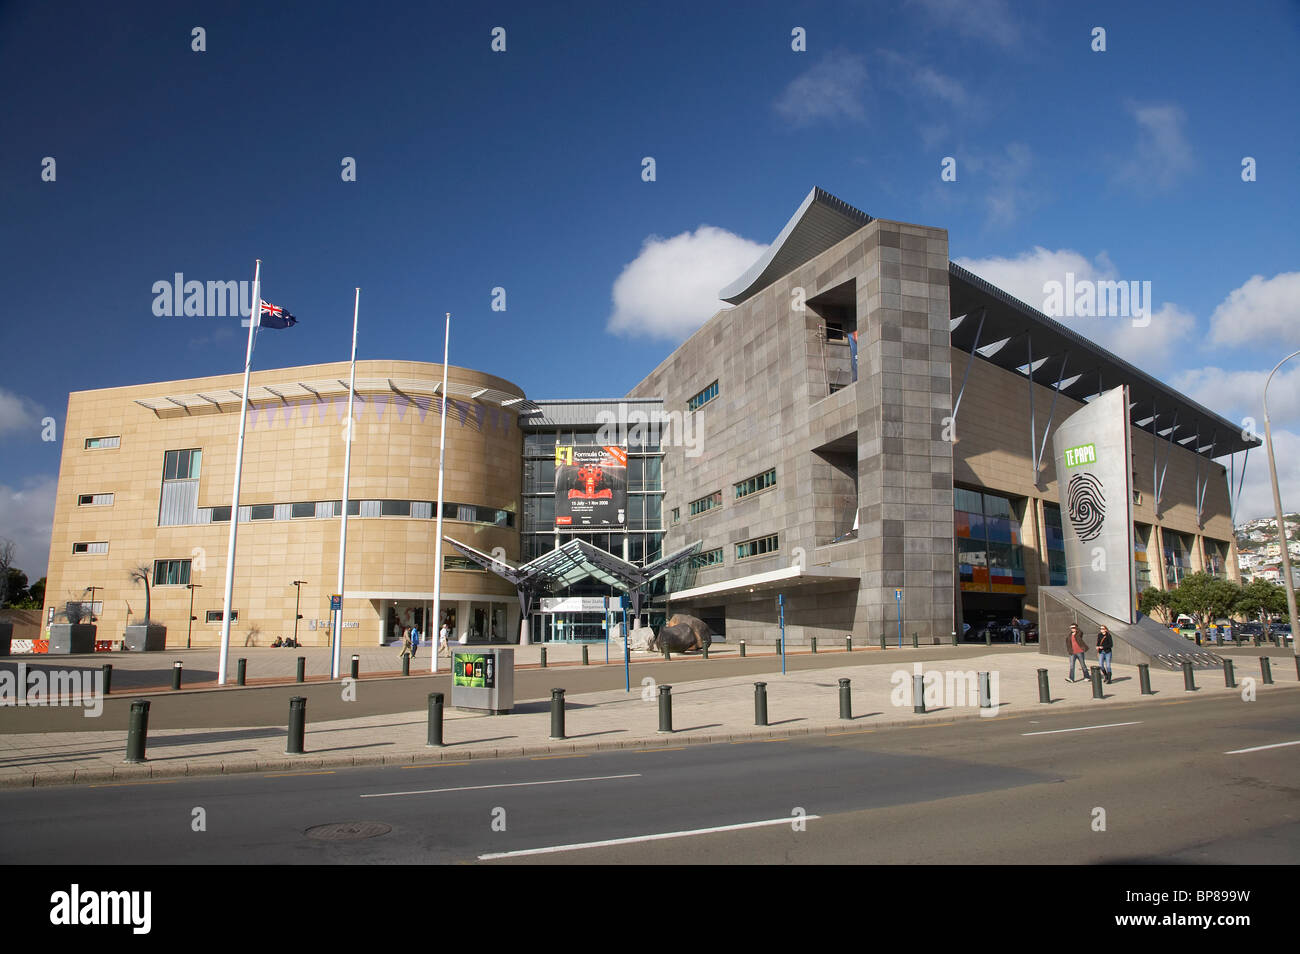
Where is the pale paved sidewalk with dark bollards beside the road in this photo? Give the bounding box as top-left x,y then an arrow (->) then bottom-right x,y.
0,650 -> 1300,788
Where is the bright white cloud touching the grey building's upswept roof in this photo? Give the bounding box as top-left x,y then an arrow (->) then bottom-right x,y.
606,225 -> 767,342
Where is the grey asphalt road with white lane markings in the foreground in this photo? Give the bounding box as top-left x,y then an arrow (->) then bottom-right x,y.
0,691 -> 1300,864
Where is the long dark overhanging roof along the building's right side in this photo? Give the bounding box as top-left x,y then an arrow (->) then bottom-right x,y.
948,263 -> 1260,458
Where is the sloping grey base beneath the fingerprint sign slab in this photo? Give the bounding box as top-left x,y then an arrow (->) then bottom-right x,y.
1039,586 -> 1223,671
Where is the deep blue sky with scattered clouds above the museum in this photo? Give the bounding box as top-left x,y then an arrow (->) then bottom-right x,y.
0,0 -> 1300,578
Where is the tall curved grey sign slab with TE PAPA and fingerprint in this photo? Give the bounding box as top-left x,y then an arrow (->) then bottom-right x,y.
1053,387 -> 1138,623
